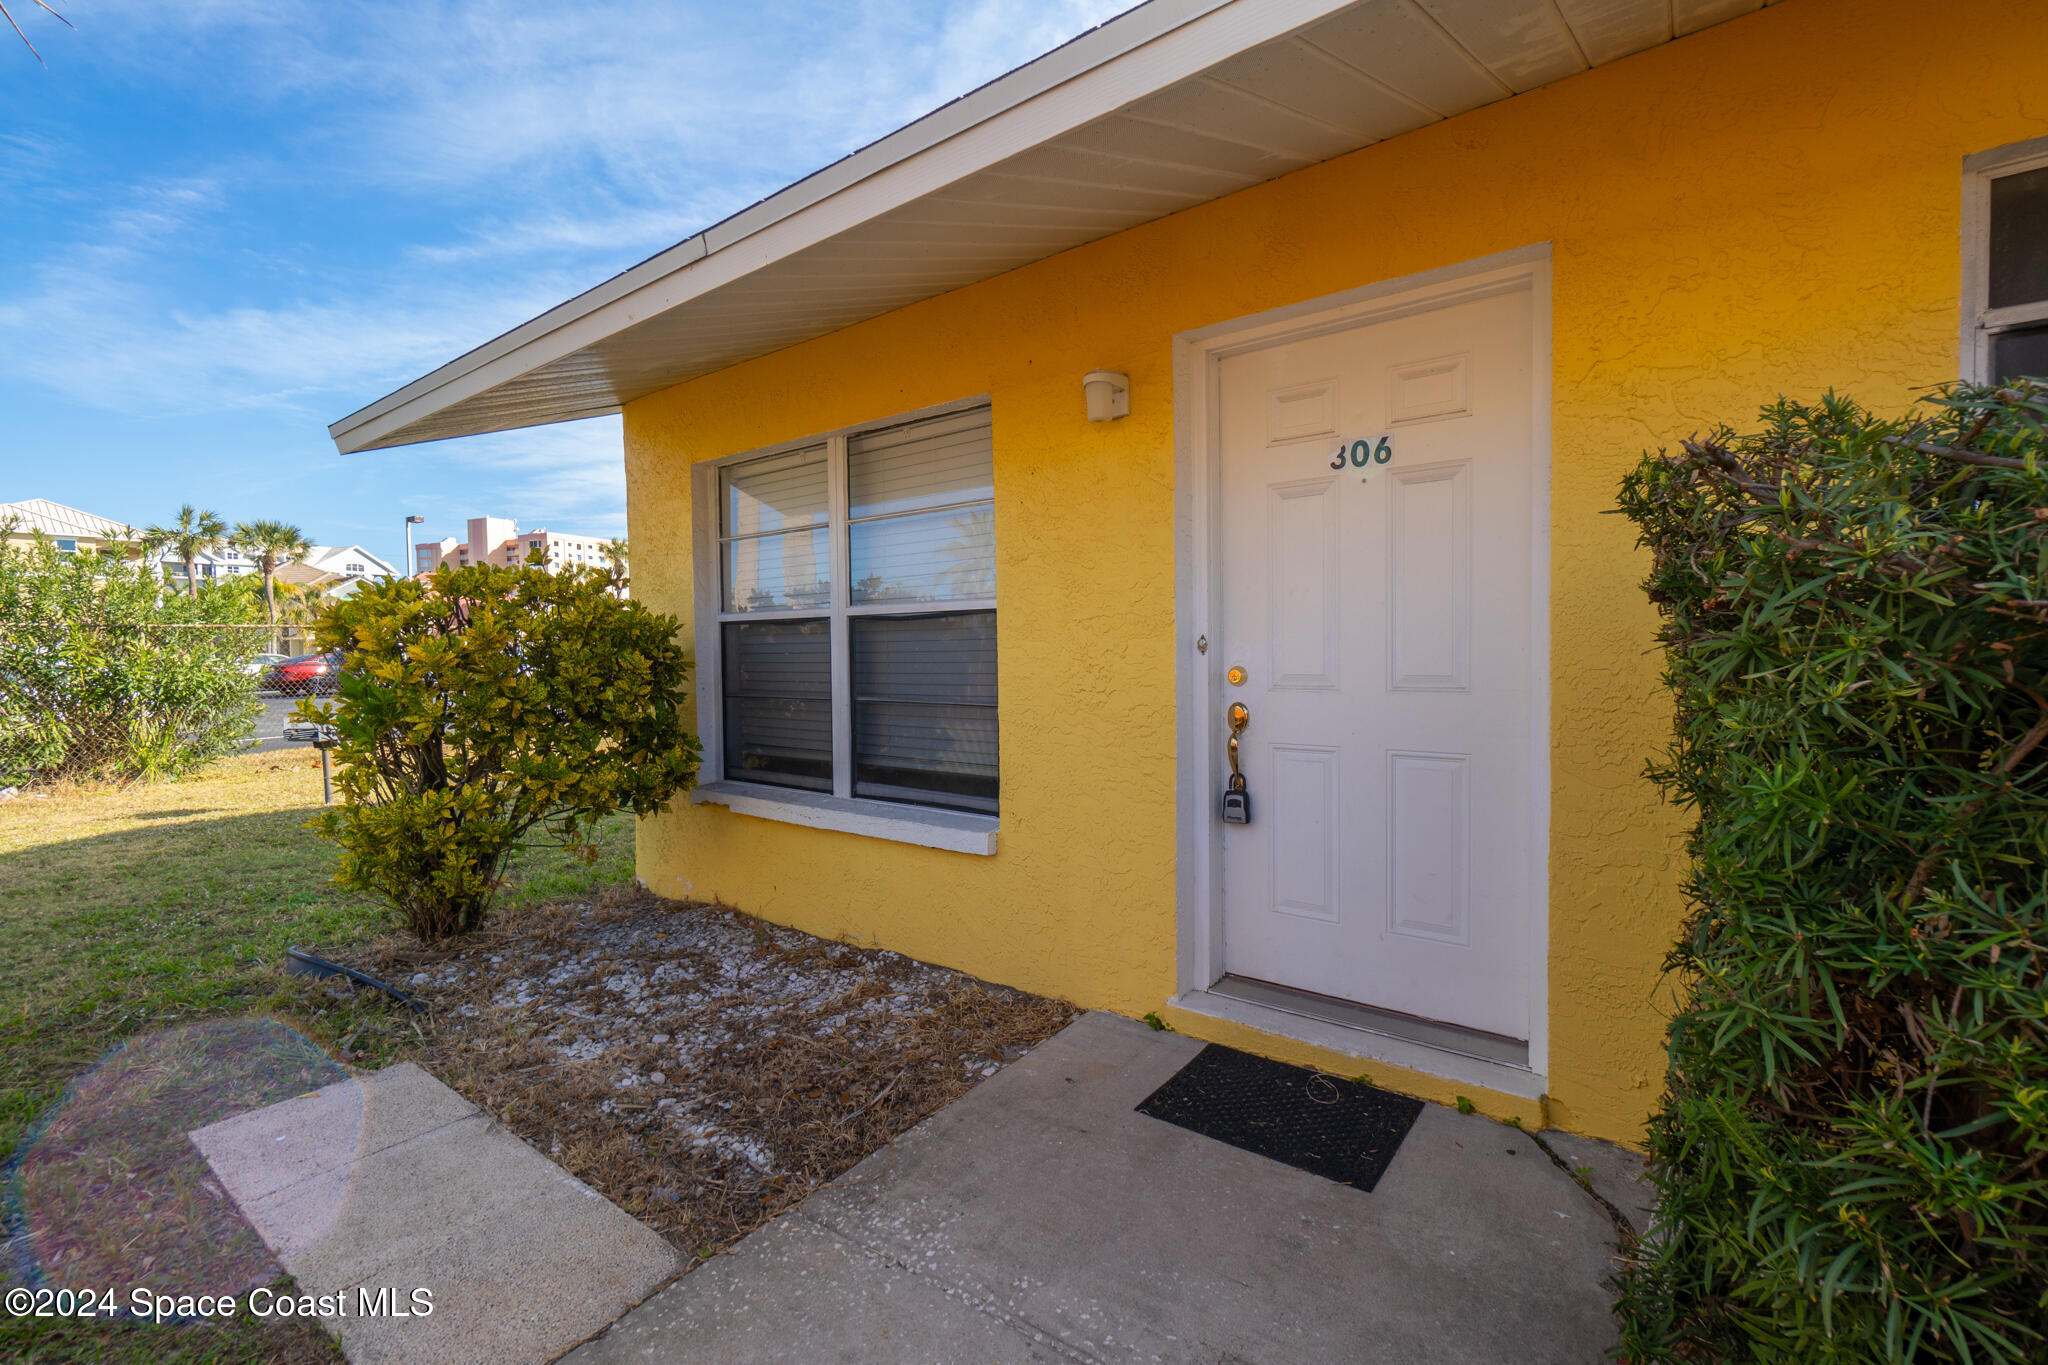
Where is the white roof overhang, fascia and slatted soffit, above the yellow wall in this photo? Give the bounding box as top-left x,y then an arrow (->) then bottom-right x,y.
328,0 -> 1772,452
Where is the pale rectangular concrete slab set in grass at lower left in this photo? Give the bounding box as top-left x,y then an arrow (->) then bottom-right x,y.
193,1062 -> 680,1365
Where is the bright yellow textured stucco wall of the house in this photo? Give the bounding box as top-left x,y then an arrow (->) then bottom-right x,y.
625,0 -> 2048,1140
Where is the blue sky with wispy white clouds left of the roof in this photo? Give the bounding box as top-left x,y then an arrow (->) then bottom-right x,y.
0,0 -> 1128,559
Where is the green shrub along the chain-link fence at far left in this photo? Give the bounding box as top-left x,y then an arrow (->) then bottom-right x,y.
0,536 -> 268,784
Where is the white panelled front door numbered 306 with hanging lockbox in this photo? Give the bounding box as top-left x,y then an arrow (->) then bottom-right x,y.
1210,289 -> 1538,1040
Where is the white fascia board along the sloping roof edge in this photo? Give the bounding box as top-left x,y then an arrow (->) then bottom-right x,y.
328,0 -> 1354,454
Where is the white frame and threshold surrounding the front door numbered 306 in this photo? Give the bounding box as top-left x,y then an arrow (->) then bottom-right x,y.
1171,241 -> 1550,1097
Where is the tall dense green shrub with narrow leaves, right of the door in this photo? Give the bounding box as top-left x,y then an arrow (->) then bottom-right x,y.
1620,385 -> 2048,1363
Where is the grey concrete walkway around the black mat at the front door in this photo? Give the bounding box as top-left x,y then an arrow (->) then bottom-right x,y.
567,1015 -> 1645,1365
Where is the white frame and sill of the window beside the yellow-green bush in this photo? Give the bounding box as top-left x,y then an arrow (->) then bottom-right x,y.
690,393 -> 1001,853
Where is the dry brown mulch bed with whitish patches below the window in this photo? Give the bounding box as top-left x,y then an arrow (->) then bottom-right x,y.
339,886 -> 1073,1257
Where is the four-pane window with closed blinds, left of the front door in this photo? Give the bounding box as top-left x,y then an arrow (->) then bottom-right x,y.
719,407 -> 997,814
